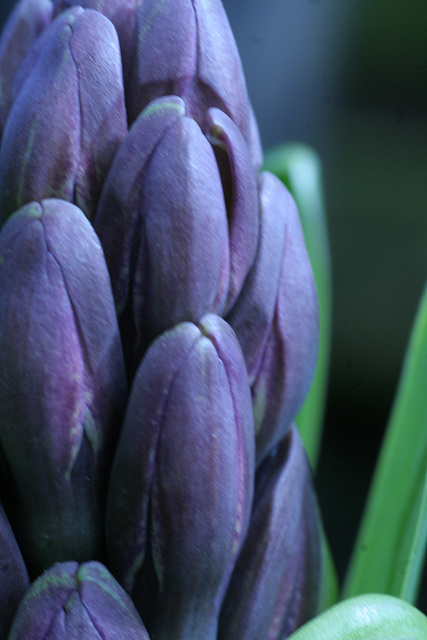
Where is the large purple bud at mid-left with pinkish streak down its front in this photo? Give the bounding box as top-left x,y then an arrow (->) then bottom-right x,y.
0,199 -> 127,572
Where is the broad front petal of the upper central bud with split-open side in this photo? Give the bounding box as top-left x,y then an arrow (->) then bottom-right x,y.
142,118 -> 229,335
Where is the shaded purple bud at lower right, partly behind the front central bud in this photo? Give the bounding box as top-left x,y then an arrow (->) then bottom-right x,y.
218,426 -> 322,640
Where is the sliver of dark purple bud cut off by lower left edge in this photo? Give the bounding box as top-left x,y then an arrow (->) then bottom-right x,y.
0,505 -> 30,638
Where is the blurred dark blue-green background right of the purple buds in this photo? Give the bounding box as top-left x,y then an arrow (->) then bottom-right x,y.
0,0 -> 427,612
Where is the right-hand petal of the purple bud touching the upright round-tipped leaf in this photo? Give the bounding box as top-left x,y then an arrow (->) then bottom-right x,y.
251,181 -> 319,462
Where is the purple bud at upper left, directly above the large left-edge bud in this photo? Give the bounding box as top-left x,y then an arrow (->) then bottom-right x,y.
0,7 -> 127,220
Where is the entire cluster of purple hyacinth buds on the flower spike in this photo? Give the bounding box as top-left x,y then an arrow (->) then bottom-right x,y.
0,0 -> 324,640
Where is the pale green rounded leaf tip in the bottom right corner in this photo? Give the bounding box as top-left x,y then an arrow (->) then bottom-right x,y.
288,594 -> 427,640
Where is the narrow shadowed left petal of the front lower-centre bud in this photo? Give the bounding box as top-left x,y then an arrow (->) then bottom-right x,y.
106,323 -> 200,592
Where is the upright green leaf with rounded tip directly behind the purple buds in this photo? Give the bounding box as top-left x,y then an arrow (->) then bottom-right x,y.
264,143 -> 332,469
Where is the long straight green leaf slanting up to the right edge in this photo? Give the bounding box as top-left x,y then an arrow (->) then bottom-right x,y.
344,278 -> 427,600
